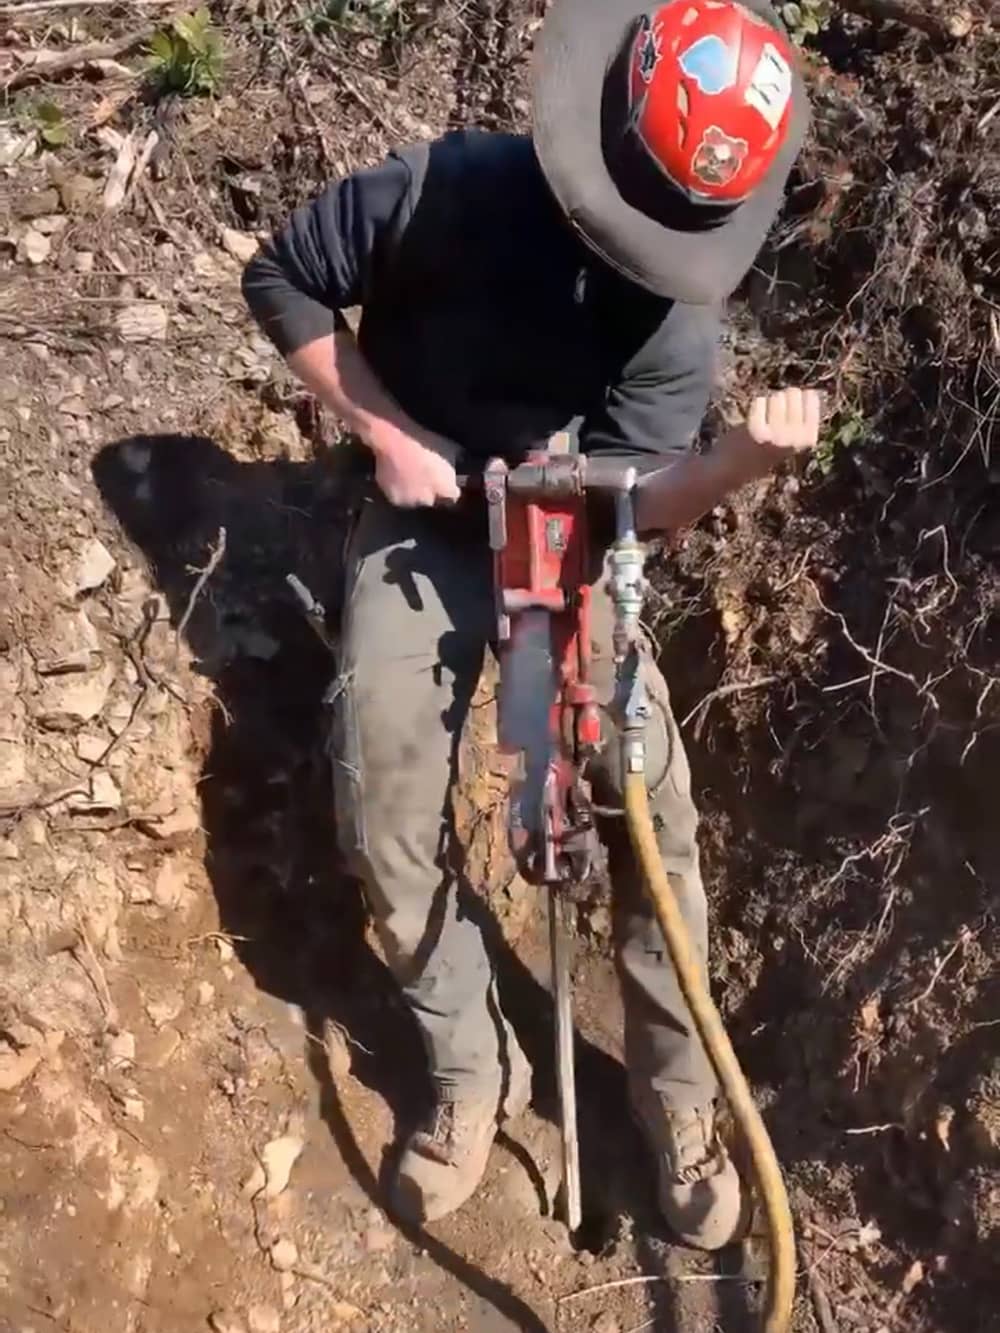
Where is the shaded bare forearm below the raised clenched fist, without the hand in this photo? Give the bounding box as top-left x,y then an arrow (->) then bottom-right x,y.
636,427 -> 777,533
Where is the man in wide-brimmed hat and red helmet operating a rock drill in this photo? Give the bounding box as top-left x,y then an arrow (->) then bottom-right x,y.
244,0 -> 819,1248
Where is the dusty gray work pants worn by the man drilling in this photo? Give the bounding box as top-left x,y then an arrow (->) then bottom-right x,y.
328,497 -> 716,1109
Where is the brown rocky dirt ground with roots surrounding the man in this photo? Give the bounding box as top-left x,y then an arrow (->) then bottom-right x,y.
0,0 -> 1000,1333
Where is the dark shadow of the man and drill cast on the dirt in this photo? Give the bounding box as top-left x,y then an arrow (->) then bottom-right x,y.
93,435 -> 743,1333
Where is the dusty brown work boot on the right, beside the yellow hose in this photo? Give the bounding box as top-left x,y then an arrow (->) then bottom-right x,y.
631,1082 -> 749,1250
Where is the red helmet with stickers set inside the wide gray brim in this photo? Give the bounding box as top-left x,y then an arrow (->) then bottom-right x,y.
629,0 -> 795,204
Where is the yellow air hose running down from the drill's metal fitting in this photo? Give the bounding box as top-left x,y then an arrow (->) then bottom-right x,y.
625,772 -> 795,1333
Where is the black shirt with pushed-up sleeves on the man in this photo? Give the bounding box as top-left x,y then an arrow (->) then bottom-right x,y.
243,131 -> 720,467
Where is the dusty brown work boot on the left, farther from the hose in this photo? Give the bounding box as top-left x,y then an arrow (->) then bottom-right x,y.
393,1037 -> 531,1222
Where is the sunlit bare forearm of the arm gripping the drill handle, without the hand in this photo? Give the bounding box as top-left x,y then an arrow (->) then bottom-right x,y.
288,329 -> 429,453
